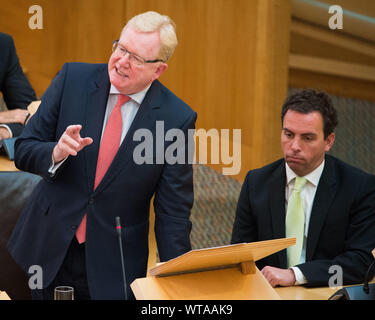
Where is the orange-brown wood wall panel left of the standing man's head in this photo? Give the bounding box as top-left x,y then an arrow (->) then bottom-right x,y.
0,0 -> 125,97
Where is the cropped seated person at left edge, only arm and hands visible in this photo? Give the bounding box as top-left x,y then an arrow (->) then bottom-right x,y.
0,32 -> 36,140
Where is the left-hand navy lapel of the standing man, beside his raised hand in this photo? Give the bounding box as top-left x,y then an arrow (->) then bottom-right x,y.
83,68 -> 110,190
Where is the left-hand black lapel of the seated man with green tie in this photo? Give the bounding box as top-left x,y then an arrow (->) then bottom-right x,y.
268,161 -> 286,267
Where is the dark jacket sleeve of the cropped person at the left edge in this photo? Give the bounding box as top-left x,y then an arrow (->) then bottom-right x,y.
0,32 -> 36,136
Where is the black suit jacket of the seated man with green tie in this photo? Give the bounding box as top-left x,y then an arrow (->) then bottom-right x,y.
232,155 -> 375,286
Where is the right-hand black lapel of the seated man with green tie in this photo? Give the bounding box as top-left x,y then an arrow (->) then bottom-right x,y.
306,156 -> 337,261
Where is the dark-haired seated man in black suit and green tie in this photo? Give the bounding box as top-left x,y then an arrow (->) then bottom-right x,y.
232,90 -> 375,287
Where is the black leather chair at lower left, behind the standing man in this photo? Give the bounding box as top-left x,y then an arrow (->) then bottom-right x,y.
0,171 -> 41,300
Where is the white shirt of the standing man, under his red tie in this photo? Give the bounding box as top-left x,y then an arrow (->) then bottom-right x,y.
48,84 -> 151,172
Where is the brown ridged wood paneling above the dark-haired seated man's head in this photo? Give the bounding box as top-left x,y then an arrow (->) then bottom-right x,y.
288,16 -> 375,101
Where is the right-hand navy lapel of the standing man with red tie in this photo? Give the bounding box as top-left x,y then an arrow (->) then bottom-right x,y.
95,80 -> 161,192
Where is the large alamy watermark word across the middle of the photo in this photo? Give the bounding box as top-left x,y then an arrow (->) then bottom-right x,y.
133,121 -> 241,175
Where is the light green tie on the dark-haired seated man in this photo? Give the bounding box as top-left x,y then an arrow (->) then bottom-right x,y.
285,177 -> 306,267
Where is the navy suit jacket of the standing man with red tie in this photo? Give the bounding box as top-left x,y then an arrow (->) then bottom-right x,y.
8,63 -> 196,299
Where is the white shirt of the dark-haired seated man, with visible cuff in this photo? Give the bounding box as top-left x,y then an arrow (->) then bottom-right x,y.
285,160 -> 324,285
